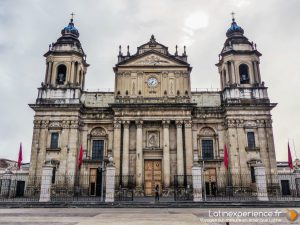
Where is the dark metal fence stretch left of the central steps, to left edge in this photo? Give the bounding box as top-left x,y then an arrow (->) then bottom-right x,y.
0,175 -> 105,202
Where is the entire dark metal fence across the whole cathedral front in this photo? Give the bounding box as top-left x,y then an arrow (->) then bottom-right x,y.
0,172 -> 300,202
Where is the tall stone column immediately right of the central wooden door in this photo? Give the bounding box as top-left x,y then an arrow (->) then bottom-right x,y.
162,120 -> 171,188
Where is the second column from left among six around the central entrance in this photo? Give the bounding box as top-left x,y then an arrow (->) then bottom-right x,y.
122,121 -> 129,177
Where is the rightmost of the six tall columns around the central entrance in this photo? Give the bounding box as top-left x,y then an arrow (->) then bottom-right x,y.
184,120 -> 193,175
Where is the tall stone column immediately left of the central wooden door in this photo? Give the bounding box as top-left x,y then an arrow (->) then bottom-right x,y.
136,121 -> 143,189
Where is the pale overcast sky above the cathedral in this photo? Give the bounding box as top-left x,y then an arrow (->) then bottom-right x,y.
0,0 -> 300,162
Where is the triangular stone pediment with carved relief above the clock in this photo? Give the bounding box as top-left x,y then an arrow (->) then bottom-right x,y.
117,51 -> 188,66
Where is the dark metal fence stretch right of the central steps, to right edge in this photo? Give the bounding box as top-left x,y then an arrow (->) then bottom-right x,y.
202,173 -> 300,201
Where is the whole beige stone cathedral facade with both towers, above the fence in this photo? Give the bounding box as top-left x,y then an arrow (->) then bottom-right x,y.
30,19 -> 276,195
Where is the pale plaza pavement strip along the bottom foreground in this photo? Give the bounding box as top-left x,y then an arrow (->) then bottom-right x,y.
0,208 -> 300,225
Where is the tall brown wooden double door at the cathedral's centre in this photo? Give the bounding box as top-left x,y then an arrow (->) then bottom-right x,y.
144,160 -> 162,196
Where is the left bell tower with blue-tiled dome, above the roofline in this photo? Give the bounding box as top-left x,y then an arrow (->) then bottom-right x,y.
42,13 -> 89,90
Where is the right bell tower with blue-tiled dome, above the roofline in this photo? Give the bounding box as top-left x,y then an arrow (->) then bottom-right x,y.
216,13 -> 263,95
